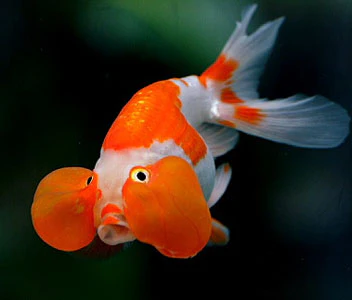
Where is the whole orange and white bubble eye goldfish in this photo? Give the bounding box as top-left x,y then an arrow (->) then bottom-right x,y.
32,5 -> 350,258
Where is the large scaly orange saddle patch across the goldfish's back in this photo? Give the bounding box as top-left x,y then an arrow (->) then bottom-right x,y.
103,80 -> 207,165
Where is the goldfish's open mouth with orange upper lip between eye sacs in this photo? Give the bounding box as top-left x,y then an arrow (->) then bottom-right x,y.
97,214 -> 136,246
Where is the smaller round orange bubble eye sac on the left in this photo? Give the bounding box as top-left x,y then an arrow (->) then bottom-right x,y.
32,167 -> 100,251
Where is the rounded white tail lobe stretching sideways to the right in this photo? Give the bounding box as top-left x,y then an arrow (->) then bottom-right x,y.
219,95 -> 350,148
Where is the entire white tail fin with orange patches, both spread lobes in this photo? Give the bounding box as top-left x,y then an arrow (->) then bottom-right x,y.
200,5 -> 350,148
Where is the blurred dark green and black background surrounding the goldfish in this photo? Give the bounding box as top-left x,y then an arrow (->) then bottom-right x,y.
0,0 -> 352,300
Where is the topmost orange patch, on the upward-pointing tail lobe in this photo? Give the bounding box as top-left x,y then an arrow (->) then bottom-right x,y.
199,54 -> 239,86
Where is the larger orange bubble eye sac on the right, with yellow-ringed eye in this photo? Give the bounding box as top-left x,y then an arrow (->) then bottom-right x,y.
122,156 -> 211,258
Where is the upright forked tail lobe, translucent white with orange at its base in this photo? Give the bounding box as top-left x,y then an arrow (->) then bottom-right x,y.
200,4 -> 284,102
